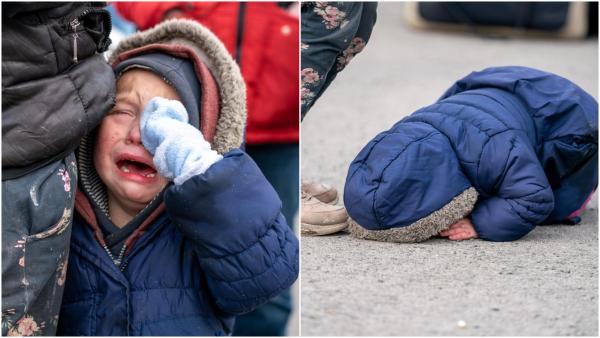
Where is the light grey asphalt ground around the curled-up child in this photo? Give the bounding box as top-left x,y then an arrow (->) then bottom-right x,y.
301,3 -> 598,336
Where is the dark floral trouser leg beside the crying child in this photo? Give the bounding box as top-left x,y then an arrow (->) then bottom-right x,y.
2,153 -> 77,336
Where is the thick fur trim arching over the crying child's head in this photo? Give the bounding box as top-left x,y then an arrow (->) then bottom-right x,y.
109,19 -> 246,154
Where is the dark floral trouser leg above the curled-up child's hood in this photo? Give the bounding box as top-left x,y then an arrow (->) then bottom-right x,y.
300,2 -> 377,119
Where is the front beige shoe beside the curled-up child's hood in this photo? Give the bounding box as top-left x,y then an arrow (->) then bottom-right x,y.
300,192 -> 348,236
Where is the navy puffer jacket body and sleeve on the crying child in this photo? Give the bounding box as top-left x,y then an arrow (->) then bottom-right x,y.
58,150 -> 298,336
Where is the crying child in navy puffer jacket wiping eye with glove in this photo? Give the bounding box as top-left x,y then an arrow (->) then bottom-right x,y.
58,20 -> 298,336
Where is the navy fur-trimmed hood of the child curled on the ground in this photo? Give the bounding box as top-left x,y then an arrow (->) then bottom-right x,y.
344,121 -> 478,242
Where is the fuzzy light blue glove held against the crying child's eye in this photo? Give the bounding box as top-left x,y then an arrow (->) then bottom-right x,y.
140,97 -> 223,185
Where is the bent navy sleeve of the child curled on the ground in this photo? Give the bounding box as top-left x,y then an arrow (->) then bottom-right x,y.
471,131 -> 554,241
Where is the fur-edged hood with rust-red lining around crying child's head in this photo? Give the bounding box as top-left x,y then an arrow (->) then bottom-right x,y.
76,19 -> 246,238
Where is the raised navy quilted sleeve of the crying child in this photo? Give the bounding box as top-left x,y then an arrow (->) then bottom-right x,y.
165,150 -> 299,315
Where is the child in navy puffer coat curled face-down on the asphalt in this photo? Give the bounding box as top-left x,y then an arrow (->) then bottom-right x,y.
344,67 -> 598,242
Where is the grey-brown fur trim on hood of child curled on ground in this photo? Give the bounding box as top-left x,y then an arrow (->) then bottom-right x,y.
348,187 -> 478,243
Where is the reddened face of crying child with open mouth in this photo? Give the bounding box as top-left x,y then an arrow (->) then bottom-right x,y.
94,69 -> 180,210
